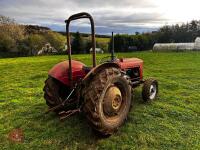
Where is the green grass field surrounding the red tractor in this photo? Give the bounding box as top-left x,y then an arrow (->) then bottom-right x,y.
0,52 -> 200,150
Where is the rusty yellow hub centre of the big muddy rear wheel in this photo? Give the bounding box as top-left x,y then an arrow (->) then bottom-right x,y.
103,86 -> 122,116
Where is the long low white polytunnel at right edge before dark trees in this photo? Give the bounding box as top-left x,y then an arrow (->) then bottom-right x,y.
153,37 -> 200,51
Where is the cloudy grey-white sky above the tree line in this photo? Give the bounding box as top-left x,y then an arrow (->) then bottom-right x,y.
0,0 -> 200,34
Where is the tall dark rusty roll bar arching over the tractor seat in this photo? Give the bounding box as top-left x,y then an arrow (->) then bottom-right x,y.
65,12 -> 96,86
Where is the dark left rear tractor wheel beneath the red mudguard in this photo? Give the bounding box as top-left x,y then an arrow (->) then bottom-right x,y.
43,76 -> 69,108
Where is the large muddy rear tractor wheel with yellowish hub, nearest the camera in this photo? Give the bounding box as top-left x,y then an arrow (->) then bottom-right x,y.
83,68 -> 131,135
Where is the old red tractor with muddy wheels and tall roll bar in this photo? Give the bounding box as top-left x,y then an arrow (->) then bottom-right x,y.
43,12 -> 158,135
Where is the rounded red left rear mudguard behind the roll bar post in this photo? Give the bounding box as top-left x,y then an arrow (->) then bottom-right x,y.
48,60 -> 86,86
